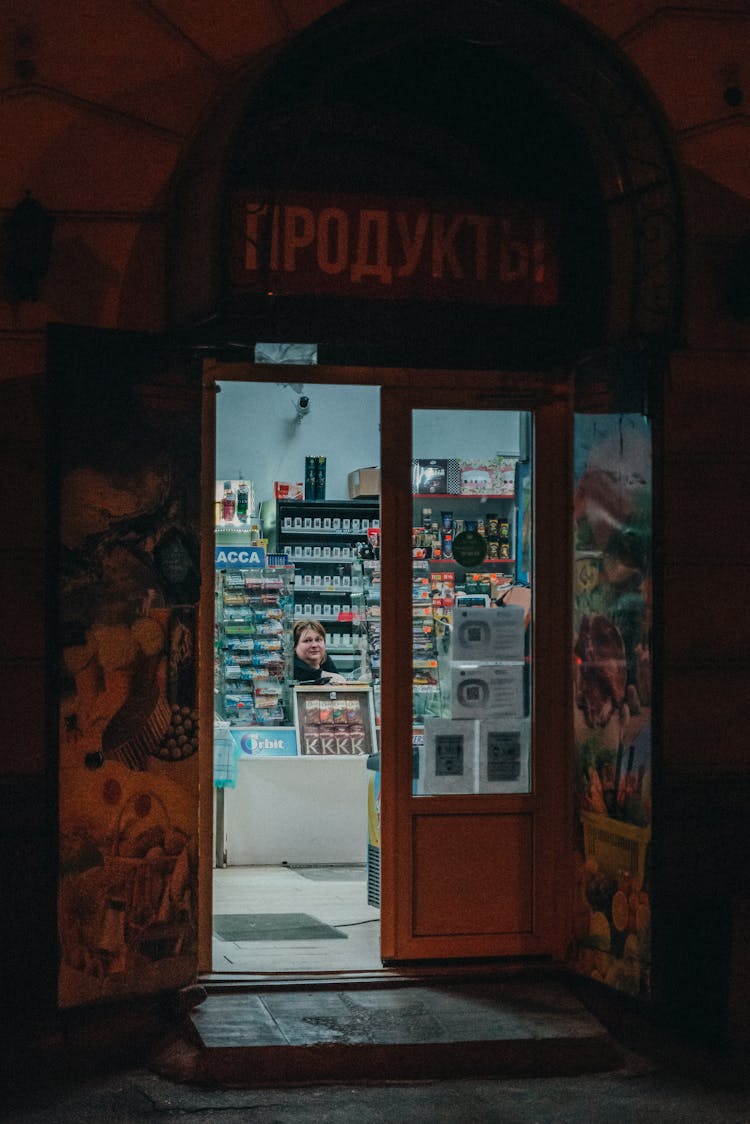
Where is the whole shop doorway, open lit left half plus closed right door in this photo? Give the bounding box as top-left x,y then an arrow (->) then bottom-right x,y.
199,368 -> 569,975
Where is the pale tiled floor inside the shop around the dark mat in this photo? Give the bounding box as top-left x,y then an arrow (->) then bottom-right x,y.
213,867 -> 381,973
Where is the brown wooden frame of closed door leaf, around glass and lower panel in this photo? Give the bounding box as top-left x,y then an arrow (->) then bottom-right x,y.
381,372 -> 573,963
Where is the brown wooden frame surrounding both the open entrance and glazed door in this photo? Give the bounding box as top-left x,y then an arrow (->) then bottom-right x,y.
199,362 -> 572,975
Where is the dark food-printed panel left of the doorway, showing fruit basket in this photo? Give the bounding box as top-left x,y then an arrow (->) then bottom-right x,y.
56,334 -> 200,1006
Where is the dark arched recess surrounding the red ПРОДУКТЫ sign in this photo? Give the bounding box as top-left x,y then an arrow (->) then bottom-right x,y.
169,0 -> 683,366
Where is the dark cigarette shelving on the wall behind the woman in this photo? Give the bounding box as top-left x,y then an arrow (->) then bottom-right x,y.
268,500 -> 380,679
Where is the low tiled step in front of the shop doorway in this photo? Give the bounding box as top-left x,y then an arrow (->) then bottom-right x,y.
178,977 -> 623,1088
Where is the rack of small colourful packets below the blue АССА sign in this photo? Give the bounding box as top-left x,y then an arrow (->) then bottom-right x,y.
214,566 -> 293,726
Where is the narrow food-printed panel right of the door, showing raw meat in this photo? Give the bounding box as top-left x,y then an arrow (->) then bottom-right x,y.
570,415 -> 652,996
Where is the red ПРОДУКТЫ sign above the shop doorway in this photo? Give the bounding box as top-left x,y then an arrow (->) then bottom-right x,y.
232,190 -> 559,307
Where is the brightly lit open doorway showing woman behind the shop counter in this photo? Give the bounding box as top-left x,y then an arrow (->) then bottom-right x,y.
211,365 -> 381,972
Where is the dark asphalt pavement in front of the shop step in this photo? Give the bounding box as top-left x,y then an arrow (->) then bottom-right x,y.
0,984 -> 750,1124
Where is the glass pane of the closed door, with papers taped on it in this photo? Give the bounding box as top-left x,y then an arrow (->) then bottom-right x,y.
412,410 -> 533,796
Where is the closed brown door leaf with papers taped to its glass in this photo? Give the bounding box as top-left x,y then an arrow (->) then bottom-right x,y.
381,372 -> 571,963
